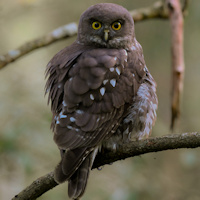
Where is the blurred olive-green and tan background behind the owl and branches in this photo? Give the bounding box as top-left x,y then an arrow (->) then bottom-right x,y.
0,0 -> 200,200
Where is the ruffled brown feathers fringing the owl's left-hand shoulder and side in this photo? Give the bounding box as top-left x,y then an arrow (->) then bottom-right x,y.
45,43 -> 92,117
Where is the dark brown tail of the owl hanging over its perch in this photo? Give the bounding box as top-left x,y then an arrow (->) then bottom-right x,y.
54,148 -> 98,200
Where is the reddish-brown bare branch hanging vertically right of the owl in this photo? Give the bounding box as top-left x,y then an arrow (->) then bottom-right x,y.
166,0 -> 187,130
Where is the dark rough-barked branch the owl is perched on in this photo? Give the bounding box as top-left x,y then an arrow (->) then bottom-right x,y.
12,132 -> 200,200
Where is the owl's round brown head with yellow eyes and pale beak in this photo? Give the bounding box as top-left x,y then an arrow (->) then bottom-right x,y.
77,3 -> 135,48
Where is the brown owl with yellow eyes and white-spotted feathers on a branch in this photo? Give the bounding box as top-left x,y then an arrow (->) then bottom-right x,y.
46,3 -> 158,199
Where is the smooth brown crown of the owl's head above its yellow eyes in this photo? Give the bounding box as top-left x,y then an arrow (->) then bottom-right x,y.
81,3 -> 132,22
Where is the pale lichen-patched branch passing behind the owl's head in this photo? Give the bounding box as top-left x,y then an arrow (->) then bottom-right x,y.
0,1 -> 169,69
